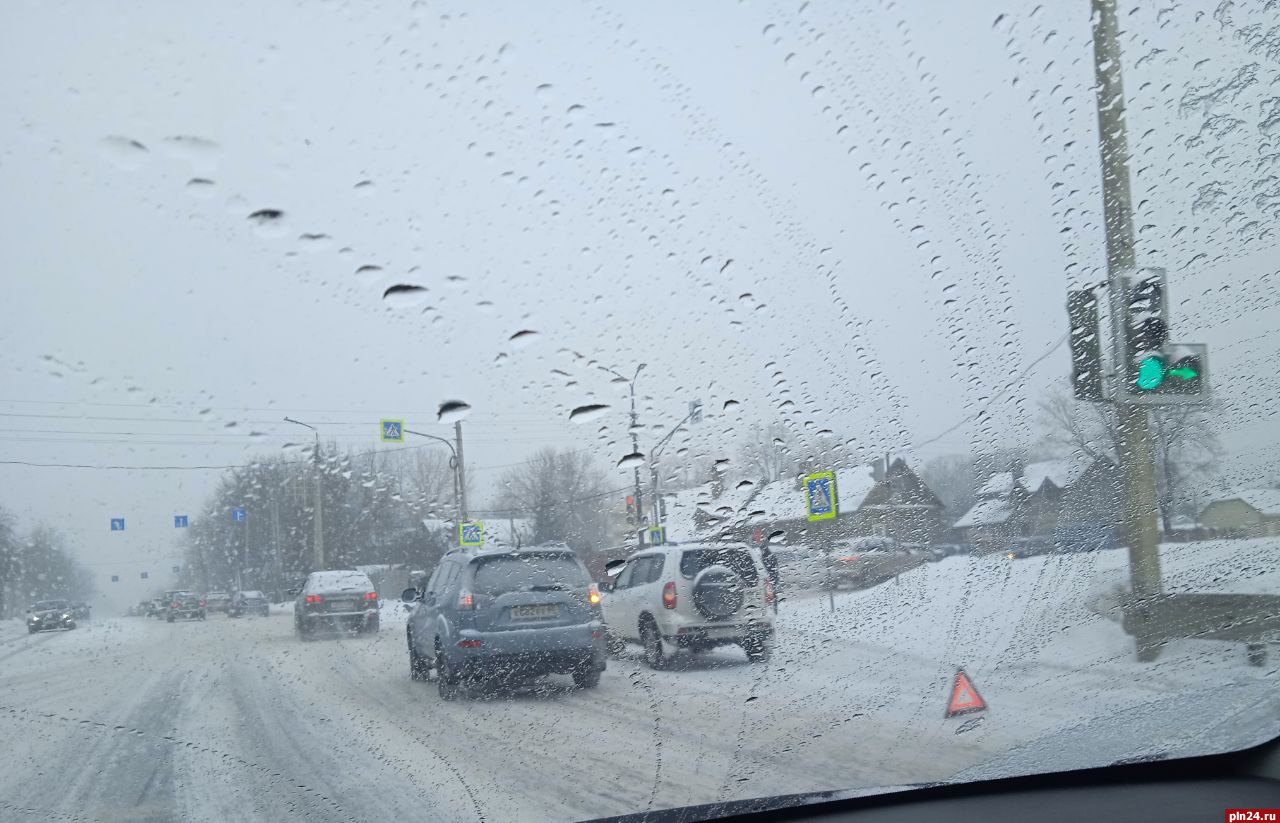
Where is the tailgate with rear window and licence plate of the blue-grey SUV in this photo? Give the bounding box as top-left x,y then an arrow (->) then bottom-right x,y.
466,552 -> 594,631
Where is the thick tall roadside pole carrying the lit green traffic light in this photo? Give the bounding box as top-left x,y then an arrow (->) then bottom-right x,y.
1092,0 -> 1161,611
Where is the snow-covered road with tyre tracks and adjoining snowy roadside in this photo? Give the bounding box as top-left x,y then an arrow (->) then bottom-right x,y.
0,541 -> 1280,822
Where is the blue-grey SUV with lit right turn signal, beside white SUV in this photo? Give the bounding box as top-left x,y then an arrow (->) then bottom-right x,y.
403,547 -> 605,700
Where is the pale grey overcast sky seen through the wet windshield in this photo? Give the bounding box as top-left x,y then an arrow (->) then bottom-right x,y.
0,0 -> 1280,596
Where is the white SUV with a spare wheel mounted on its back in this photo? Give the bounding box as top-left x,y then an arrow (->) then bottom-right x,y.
602,544 -> 774,668
